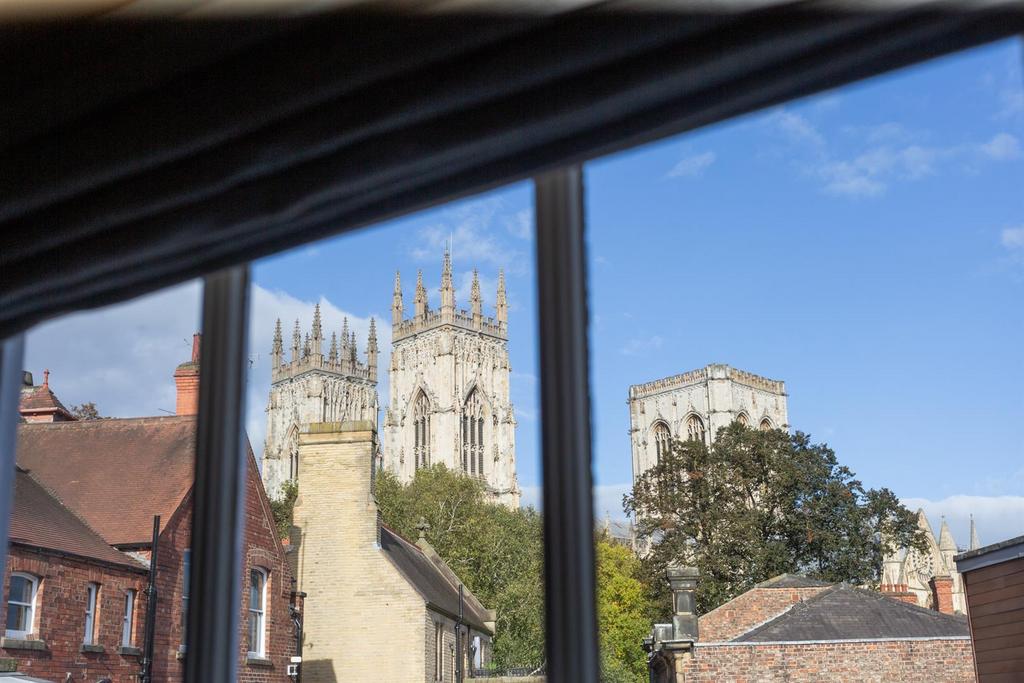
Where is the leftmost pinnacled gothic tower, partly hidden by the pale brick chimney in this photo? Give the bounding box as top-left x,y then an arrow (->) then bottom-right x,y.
262,304 -> 378,498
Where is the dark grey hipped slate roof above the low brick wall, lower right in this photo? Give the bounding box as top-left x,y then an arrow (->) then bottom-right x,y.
733,584 -> 969,642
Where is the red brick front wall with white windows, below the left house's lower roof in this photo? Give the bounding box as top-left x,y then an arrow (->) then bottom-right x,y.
0,545 -> 148,683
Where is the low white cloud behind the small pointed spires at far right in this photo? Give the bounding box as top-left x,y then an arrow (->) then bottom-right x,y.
902,496 -> 1024,548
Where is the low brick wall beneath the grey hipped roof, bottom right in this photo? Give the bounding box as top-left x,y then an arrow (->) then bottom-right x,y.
678,638 -> 975,683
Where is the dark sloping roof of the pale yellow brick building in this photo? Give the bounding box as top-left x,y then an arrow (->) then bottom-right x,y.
381,526 -> 493,635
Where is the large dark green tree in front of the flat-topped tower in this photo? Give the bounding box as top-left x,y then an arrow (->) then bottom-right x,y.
624,423 -> 925,611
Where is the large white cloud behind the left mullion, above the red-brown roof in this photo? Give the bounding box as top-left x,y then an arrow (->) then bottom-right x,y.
26,282 -> 391,456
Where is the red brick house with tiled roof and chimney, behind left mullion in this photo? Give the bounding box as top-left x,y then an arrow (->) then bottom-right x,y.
6,338 -> 295,683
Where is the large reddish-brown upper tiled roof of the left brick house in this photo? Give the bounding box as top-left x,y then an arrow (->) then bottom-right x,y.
16,416 -> 196,546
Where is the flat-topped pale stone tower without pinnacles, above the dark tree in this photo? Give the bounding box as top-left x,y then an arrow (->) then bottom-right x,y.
629,364 -> 790,481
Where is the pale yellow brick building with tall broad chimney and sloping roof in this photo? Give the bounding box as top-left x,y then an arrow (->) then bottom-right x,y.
291,421 -> 497,683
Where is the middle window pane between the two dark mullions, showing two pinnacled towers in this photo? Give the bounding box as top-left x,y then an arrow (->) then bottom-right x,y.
247,183 -> 545,681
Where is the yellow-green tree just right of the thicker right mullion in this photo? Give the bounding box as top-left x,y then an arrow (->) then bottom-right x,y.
595,535 -> 657,683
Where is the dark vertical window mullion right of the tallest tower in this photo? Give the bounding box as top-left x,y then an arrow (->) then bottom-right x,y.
534,166 -> 598,683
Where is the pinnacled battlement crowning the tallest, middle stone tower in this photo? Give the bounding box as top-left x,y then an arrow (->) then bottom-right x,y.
391,250 -> 508,342
